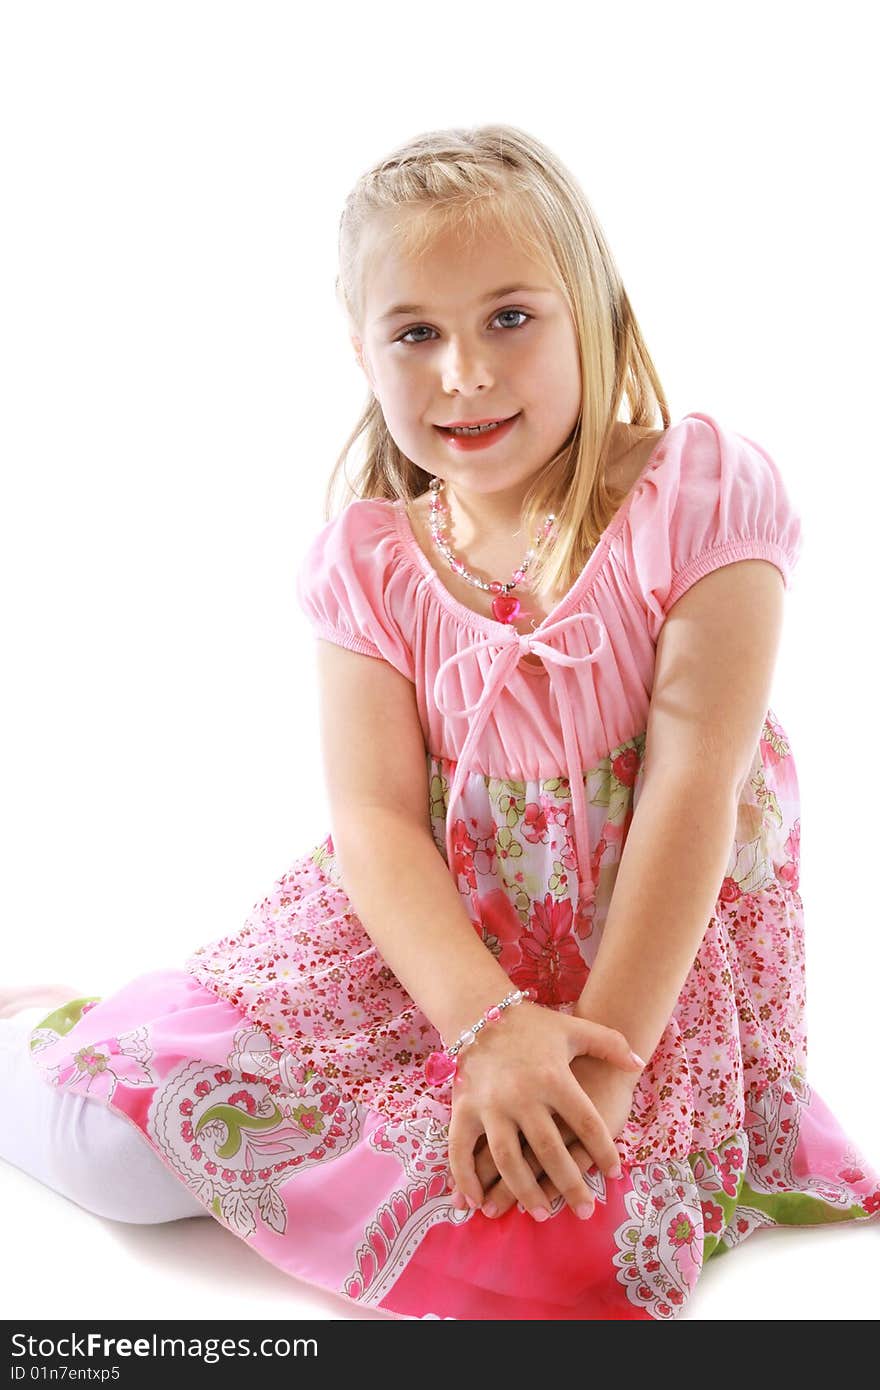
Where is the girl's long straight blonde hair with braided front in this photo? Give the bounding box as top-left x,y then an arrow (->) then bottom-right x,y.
325,125 -> 670,606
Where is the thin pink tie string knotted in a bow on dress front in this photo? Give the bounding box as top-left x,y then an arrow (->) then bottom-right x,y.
434,610 -> 608,901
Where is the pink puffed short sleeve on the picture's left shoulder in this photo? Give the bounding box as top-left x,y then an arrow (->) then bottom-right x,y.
296,498 -> 414,680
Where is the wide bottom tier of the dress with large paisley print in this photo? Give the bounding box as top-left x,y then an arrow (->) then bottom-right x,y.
31,928 -> 880,1319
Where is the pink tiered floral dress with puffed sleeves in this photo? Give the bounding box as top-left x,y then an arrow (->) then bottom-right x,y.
31,413 -> 880,1319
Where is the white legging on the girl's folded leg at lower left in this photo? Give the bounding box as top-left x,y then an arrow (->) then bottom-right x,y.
0,1004 -> 210,1225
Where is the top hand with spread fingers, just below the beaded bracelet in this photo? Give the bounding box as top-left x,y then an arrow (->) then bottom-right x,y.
449,1001 -> 641,1215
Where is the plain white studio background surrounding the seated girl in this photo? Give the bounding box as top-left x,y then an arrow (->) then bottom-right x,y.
0,0 -> 880,1319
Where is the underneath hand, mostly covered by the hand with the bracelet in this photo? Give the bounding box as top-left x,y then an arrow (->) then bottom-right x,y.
453,1056 -> 639,1216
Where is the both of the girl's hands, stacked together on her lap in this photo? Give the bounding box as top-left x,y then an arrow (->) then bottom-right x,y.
449,1002 -> 642,1219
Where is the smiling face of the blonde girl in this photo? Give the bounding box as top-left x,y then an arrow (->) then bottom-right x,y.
352,211 -> 581,507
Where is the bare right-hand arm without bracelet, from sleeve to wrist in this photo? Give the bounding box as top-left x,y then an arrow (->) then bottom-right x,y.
574,559 -> 784,1058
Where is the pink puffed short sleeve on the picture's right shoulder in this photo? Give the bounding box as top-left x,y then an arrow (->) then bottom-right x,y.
628,414 -> 801,639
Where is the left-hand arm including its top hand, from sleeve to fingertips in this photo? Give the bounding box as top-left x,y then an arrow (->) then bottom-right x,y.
317,639 -> 634,1208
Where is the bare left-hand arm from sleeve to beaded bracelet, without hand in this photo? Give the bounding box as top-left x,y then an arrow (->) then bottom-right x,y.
317,639 -> 512,1043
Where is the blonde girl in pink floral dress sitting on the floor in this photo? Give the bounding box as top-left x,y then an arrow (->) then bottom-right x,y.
0,126 -> 880,1319
